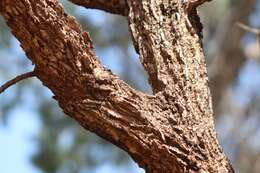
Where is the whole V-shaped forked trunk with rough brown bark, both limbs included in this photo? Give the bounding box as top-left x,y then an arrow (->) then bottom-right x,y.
0,0 -> 233,173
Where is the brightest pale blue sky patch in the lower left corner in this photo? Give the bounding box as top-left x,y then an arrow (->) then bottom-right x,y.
0,107 -> 40,173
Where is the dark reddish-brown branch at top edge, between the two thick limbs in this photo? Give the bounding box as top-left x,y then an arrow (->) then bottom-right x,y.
70,0 -> 128,16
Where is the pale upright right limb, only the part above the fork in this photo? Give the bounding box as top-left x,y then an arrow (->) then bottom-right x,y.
128,0 -> 209,93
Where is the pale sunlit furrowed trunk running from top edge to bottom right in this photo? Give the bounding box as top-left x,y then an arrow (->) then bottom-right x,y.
127,0 -> 232,172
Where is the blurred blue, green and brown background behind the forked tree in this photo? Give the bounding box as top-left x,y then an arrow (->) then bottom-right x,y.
0,0 -> 260,173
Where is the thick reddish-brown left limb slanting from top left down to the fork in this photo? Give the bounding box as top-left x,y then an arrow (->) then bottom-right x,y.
1,0 -> 152,167
